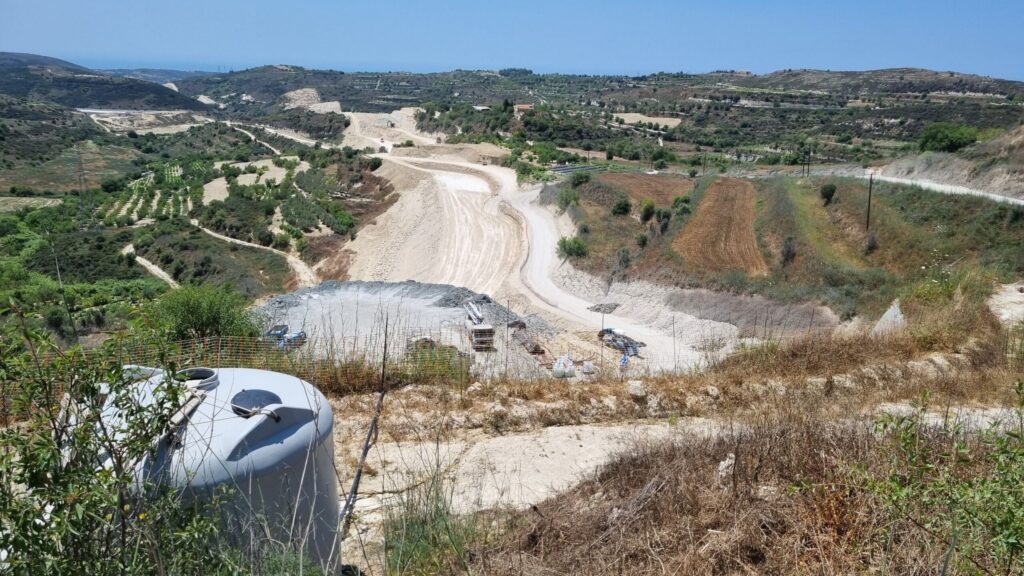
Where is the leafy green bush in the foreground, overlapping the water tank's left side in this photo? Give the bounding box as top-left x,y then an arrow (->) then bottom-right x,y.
0,331 -> 230,575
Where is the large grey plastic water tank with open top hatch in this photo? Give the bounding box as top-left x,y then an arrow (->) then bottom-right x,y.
115,368 -> 340,569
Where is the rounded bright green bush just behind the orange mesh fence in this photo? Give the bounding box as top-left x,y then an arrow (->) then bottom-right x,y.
151,285 -> 261,340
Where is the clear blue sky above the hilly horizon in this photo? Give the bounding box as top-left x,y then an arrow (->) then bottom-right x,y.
6,0 -> 1024,80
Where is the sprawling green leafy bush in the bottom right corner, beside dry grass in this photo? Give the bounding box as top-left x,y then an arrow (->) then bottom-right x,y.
869,382 -> 1024,574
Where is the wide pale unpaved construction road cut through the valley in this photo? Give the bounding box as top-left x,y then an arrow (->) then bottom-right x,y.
346,115 -> 729,369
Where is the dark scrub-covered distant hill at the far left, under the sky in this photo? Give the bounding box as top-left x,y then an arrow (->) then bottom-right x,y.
0,52 -> 206,110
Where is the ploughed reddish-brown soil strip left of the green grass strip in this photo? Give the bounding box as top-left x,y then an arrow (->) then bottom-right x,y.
673,178 -> 768,276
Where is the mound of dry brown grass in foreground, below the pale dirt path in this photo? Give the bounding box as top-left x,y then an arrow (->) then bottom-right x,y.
473,403 -> 1019,575
